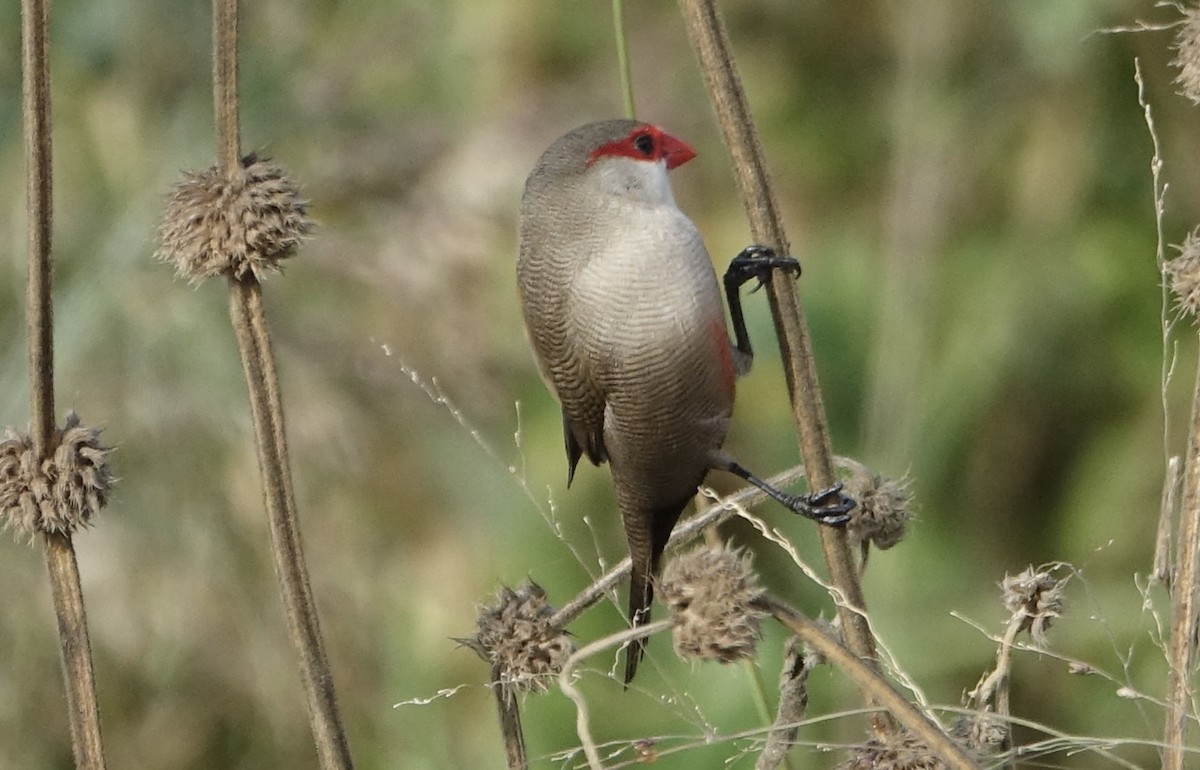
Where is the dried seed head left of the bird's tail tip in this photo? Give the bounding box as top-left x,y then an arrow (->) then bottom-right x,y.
457,580 -> 575,692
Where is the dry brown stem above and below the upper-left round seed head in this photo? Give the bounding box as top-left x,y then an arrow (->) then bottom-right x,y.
212,0 -> 354,770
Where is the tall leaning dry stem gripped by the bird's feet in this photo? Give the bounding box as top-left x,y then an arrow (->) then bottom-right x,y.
679,0 -> 893,734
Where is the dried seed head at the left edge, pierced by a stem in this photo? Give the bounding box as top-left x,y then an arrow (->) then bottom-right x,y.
0,411 -> 114,537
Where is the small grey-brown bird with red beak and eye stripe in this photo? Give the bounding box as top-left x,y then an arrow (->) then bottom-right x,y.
516,119 -> 854,687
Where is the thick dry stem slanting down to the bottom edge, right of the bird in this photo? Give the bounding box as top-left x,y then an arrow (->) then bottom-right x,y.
762,596 -> 979,770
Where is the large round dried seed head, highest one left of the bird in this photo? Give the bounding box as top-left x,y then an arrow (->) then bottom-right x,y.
155,154 -> 312,283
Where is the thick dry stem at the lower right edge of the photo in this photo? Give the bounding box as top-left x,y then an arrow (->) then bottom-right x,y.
1163,345 -> 1200,770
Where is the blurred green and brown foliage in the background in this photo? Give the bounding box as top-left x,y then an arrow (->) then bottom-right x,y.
0,0 -> 1200,769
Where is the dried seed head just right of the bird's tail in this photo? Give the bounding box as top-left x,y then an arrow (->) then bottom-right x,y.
659,547 -> 767,663
